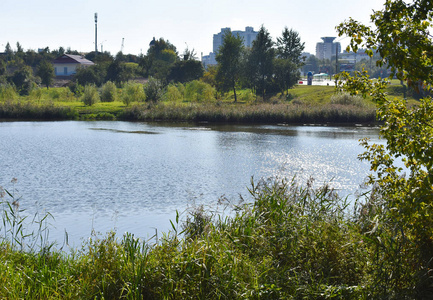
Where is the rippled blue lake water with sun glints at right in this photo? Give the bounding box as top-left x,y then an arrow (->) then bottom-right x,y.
0,121 -> 378,246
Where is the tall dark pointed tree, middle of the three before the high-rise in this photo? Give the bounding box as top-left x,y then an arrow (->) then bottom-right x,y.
248,25 -> 275,100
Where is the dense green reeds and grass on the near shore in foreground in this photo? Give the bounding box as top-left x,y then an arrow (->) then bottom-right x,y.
0,177 -> 431,299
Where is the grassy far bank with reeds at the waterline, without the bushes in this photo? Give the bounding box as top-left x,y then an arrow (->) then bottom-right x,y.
0,86 -> 382,124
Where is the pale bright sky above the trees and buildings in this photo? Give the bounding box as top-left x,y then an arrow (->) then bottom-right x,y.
0,0 -> 384,57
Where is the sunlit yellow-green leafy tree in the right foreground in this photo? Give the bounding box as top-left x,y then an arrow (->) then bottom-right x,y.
337,0 -> 433,299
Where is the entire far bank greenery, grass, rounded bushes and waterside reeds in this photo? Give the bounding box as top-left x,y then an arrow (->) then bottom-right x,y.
0,81 -> 416,124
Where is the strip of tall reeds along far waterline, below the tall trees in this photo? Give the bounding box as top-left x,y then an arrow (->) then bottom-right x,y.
120,102 -> 376,124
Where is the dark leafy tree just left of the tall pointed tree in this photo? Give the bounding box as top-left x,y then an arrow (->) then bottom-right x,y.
215,31 -> 244,102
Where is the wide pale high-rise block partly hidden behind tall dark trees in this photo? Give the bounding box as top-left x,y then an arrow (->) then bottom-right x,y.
201,26 -> 258,67
